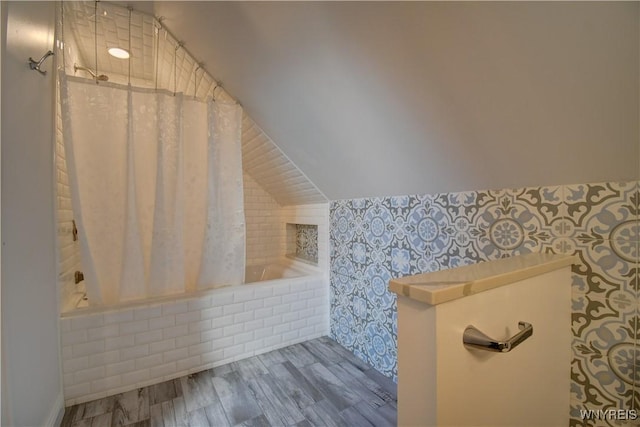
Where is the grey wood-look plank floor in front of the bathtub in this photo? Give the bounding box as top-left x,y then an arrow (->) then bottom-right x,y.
62,337 -> 397,427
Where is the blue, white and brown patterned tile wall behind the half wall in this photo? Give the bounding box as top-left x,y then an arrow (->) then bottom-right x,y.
330,182 -> 640,425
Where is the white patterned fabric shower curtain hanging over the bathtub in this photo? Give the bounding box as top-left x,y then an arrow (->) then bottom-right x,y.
60,74 -> 245,305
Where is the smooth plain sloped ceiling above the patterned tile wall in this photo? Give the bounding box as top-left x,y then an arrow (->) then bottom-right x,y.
154,1 -> 640,199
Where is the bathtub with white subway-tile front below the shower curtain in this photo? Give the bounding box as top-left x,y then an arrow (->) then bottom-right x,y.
60,259 -> 329,406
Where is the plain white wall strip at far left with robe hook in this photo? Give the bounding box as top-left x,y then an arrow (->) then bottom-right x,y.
1,2 -> 63,426
